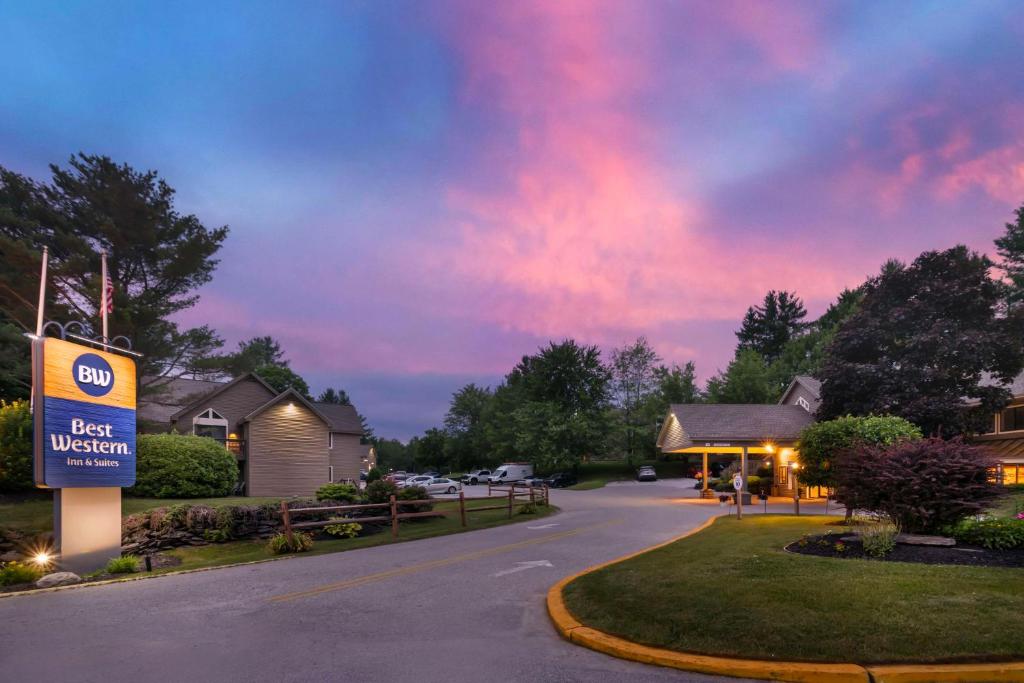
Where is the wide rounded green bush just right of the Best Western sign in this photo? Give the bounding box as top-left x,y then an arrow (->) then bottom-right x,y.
129,434 -> 239,498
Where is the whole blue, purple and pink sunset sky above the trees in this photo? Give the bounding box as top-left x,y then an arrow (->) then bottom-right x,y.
0,0 -> 1024,439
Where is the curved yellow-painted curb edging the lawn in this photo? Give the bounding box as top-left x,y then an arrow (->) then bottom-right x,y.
547,516 -> 1024,683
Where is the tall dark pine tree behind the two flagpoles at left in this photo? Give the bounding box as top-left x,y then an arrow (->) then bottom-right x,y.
0,154 -> 227,392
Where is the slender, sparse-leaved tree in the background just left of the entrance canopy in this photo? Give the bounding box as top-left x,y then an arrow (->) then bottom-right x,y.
608,337 -> 662,463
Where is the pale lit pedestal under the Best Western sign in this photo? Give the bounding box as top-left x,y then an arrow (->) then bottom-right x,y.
53,486 -> 121,573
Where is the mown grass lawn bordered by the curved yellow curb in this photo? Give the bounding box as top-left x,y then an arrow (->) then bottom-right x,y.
565,515 -> 1024,664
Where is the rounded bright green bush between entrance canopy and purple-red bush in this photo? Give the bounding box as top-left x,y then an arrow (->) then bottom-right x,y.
798,416 -> 921,488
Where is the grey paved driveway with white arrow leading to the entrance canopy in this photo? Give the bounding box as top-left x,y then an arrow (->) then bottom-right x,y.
0,481 -> 794,683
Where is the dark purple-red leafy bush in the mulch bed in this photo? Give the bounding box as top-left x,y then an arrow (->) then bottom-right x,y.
836,438 -> 1001,533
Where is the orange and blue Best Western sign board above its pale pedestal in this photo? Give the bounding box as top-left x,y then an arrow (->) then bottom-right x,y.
33,338 -> 135,488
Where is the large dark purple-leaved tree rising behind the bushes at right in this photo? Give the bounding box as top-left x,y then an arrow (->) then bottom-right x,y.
818,246 -> 1024,436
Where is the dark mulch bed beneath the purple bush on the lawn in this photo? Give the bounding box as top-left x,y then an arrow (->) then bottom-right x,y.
784,533 -> 1024,567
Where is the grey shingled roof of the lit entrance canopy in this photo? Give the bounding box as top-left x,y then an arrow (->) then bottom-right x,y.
658,403 -> 814,450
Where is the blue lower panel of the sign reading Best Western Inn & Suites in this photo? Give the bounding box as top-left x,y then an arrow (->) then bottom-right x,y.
43,396 -> 135,488
